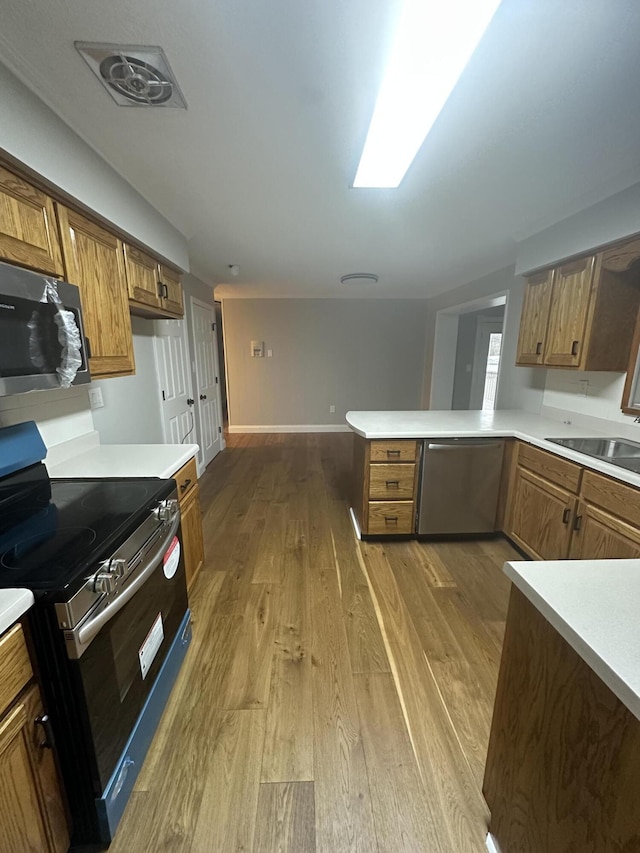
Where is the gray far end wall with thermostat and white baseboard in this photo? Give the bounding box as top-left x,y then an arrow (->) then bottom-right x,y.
223,299 -> 426,427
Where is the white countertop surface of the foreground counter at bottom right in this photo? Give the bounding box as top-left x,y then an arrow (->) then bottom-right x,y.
504,560 -> 640,720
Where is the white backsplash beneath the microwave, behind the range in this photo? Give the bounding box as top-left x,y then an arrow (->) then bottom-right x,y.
0,387 -> 94,447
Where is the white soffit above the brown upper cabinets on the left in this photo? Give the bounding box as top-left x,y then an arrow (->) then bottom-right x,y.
0,64 -> 189,270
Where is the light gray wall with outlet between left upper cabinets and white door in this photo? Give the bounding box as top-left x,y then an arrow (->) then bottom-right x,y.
91,317 -> 164,444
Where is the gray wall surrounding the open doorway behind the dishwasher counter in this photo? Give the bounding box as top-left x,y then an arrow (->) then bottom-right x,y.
422,267 -> 546,413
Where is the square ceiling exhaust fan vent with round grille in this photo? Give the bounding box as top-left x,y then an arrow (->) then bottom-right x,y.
75,41 -> 187,110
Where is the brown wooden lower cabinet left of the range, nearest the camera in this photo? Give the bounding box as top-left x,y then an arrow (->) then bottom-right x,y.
0,624 -> 69,853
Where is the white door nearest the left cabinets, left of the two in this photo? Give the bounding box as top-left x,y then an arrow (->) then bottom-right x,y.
154,320 -> 197,444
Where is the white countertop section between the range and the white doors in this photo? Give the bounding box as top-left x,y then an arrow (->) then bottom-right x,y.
45,444 -> 198,479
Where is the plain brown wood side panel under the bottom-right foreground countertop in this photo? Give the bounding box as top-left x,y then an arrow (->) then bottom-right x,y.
483,587 -> 640,853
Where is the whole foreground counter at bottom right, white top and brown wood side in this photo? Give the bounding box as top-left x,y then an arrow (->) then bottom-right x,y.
483,560 -> 640,853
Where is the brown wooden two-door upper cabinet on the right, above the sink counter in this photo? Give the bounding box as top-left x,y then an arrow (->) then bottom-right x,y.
516,241 -> 640,372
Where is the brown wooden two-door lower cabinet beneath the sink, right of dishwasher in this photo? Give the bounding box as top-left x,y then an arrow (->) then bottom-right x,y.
504,442 -> 640,560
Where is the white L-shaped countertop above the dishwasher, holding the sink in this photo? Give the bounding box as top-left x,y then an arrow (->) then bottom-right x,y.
346,409 -> 640,488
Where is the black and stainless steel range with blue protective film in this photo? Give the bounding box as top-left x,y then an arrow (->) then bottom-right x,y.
0,424 -> 191,845
